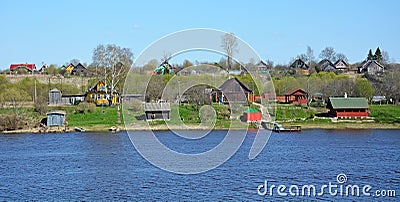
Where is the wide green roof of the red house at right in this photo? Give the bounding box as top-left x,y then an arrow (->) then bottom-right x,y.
329,97 -> 369,109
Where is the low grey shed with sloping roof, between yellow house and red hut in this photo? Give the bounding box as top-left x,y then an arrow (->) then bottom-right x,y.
144,103 -> 171,121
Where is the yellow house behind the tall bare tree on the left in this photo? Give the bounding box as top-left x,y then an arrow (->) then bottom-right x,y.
85,81 -> 119,106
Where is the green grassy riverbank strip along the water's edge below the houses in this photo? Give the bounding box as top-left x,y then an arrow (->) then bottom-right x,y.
0,105 -> 400,132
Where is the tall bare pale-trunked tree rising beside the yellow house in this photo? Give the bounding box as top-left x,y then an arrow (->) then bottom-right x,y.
92,44 -> 133,104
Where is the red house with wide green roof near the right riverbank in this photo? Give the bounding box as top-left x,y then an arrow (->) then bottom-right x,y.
327,96 -> 369,118
